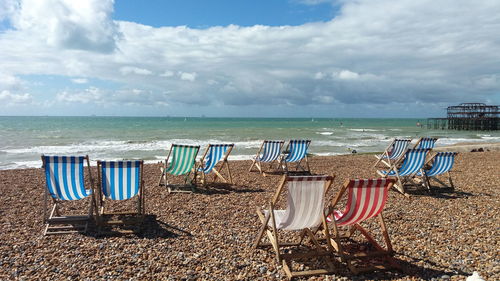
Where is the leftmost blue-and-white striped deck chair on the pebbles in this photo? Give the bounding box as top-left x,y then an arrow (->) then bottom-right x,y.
42,155 -> 98,235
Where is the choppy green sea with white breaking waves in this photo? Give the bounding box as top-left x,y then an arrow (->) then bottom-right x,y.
0,116 -> 500,170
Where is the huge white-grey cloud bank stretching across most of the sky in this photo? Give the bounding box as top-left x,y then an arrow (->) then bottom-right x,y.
0,0 -> 500,115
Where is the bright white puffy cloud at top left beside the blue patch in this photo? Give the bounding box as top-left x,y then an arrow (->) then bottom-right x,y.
9,0 -> 119,53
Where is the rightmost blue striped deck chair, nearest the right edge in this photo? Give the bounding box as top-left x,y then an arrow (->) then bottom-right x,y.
416,152 -> 458,191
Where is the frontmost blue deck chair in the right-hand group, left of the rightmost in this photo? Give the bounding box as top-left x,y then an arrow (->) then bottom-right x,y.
377,149 -> 430,196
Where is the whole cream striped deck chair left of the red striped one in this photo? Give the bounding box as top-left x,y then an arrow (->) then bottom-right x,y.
253,175 -> 334,278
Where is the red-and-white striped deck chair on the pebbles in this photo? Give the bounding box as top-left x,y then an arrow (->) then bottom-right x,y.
327,178 -> 398,274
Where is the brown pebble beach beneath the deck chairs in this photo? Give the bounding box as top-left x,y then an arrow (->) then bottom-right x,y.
0,151 -> 500,280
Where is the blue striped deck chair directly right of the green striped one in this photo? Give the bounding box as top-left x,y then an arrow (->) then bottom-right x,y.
198,143 -> 234,184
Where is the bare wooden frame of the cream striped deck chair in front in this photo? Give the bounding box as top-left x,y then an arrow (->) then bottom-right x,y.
253,175 -> 334,279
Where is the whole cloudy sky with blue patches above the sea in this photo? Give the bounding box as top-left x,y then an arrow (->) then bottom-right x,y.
0,0 -> 500,118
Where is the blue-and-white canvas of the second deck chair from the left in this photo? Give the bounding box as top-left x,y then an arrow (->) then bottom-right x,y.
100,160 -> 142,200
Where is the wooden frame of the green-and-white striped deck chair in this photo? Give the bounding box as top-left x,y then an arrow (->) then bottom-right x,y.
158,144 -> 200,193
